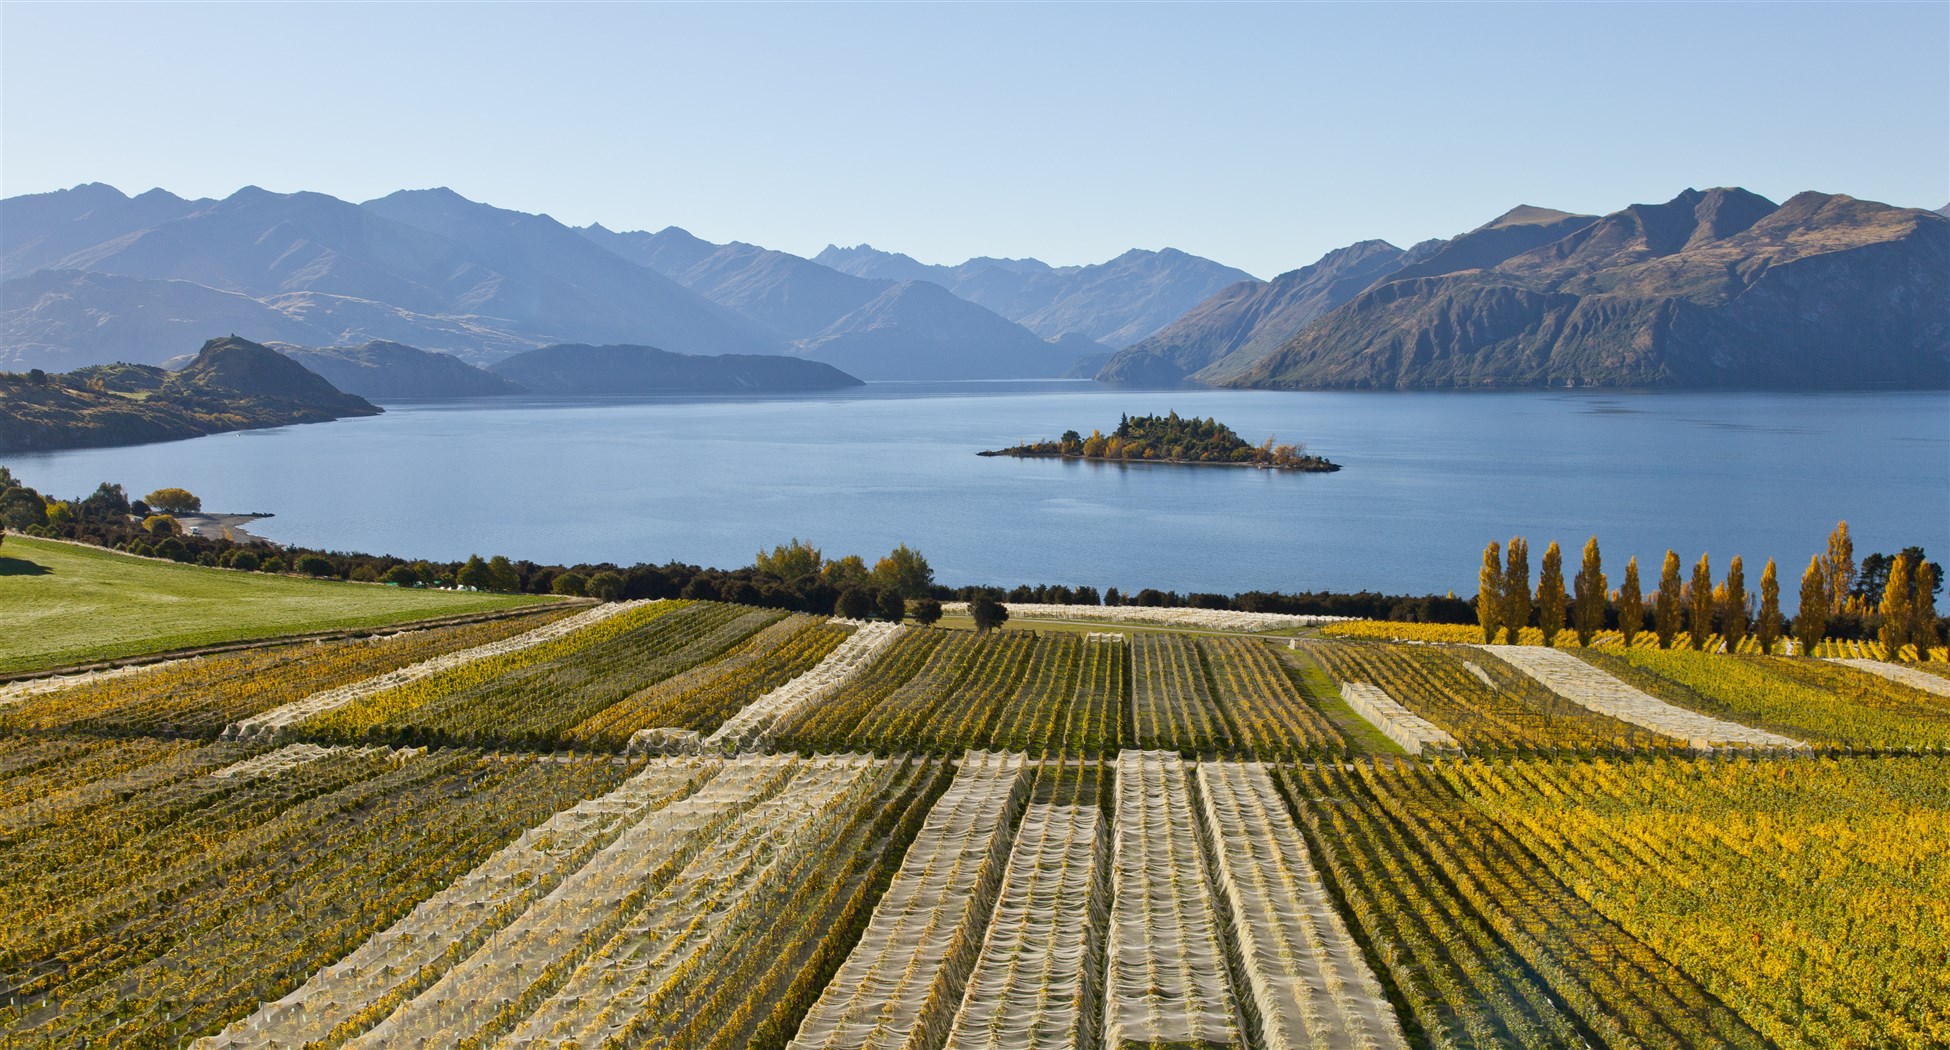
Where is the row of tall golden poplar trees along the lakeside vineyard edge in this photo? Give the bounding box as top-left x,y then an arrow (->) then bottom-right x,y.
1476,521 -> 1936,660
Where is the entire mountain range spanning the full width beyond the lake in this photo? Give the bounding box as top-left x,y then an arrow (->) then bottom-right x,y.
0,183 -> 1950,390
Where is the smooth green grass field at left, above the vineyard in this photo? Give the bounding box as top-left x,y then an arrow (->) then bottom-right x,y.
0,537 -> 565,673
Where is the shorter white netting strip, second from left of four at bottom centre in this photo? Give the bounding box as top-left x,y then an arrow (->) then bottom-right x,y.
948,804 -> 1110,1050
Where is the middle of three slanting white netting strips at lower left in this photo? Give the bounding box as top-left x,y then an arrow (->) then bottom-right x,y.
349,757 -> 805,1048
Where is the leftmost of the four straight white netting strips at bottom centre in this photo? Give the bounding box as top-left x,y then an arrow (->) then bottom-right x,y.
792,751 -> 1030,1050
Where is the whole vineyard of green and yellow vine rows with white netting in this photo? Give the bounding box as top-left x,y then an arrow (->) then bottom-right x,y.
0,601 -> 1950,1050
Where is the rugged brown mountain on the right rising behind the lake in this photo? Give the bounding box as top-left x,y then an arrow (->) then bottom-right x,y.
1098,189 -> 1950,388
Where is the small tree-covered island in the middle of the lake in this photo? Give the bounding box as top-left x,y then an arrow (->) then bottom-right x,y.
975,412 -> 1340,472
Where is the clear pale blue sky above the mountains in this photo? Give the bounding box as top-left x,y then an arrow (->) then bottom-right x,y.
0,0 -> 1950,277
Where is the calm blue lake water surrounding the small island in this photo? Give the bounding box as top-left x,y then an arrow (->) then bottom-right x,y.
8,381 -> 1950,595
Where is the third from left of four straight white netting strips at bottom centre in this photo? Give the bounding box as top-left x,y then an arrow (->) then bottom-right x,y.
1104,751 -> 1246,1050
